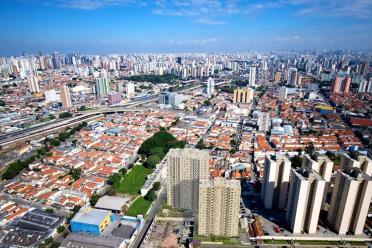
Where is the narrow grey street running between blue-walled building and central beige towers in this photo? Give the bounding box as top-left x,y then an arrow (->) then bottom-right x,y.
130,186 -> 167,248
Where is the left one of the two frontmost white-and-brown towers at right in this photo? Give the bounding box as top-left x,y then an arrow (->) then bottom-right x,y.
285,169 -> 326,233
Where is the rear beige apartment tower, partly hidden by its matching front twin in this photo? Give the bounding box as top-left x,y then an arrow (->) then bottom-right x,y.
166,148 -> 209,210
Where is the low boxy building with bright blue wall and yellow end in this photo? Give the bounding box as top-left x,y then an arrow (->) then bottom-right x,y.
70,206 -> 111,235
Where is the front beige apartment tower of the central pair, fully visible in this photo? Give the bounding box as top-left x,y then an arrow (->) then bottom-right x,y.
198,177 -> 240,237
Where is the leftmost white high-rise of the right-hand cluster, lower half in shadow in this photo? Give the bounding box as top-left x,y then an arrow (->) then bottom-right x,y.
261,155 -> 291,209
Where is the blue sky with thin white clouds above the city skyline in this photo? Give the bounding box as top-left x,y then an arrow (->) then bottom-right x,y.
0,0 -> 372,55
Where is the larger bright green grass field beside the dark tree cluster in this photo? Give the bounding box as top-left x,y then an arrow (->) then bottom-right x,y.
114,165 -> 153,195
